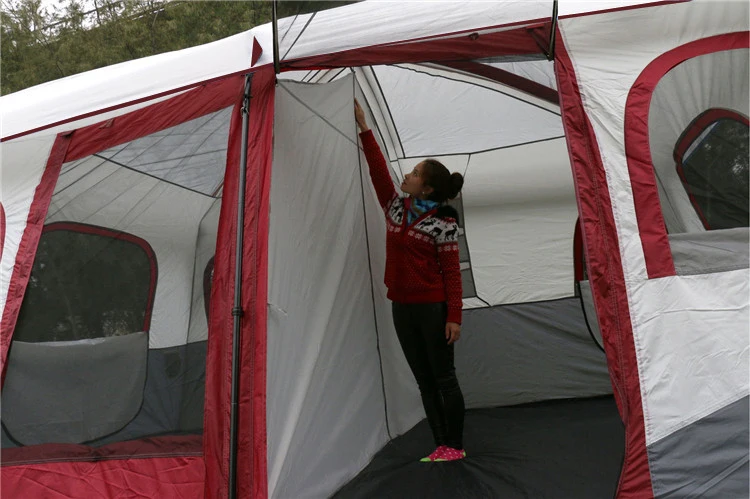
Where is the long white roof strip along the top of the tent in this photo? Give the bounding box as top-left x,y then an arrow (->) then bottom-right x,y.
0,0 -> 676,140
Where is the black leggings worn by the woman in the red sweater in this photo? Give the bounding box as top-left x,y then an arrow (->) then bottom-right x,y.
393,302 -> 464,449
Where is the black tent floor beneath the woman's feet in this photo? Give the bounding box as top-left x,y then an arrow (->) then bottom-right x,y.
334,397 -> 625,499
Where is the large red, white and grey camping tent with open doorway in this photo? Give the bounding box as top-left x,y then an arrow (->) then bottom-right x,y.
0,0 -> 750,498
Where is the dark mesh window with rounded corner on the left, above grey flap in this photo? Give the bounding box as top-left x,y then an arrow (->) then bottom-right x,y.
13,224 -> 156,343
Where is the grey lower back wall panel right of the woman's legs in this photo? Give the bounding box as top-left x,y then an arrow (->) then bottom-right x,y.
456,298 -> 612,408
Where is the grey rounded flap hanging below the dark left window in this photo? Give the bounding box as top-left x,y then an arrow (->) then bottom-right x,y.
2,332 -> 148,445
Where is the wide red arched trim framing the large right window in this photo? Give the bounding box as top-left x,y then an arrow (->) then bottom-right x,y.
625,31 -> 750,279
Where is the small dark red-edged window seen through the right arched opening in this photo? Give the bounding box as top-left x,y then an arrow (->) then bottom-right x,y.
677,118 -> 749,229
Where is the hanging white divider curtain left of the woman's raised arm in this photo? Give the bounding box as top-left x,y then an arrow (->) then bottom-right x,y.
267,77 -> 387,498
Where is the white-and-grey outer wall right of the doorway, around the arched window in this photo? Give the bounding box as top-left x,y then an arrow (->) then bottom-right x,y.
560,0 -> 750,497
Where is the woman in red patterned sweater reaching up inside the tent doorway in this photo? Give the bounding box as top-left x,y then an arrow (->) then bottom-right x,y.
354,100 -> 466,462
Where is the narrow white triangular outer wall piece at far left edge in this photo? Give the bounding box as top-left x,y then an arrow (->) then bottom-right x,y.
0,136 -> 55,317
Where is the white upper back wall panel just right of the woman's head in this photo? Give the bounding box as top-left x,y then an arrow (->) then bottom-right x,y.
462,139 -> 578,305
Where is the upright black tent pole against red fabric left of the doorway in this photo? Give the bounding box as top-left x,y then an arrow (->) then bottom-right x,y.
228,74 -> 251,499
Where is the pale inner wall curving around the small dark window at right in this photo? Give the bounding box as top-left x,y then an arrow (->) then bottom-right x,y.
648,49 -> 750,234
